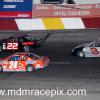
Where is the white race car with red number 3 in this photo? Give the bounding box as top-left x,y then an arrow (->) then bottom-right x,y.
72,40 -> 100,57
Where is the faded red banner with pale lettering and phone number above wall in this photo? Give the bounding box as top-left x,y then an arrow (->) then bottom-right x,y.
33,4 -> 100,18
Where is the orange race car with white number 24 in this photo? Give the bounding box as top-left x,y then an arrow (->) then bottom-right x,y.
0,52 -> 49,72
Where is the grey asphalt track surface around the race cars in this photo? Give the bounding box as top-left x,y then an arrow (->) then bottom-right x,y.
0,30 -> 100,100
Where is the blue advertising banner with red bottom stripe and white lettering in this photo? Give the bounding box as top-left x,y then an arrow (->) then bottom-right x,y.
0,0 -> 32,18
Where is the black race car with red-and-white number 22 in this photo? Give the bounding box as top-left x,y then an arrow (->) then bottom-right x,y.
0,34 -> 47,52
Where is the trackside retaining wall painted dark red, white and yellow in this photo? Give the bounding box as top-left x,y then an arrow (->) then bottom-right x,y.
0,18 -> 100,31
